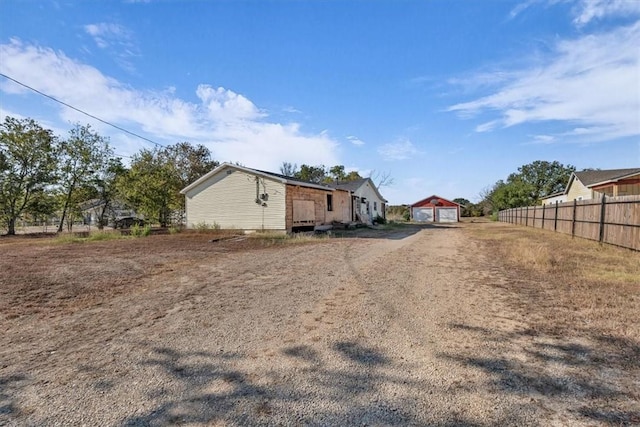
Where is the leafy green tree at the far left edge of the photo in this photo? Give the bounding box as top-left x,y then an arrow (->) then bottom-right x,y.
0,116 -> 56,235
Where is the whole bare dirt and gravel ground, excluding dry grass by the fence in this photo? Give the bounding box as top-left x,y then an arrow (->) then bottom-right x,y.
0,224 -> 640,426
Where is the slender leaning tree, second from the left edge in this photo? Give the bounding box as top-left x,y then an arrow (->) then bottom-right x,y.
58,124 -> 113,233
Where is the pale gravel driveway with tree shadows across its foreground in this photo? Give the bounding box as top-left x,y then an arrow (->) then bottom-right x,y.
0,227 -> 608,426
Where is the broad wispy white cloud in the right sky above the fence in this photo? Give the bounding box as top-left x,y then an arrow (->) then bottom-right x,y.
448,22 -> 640,140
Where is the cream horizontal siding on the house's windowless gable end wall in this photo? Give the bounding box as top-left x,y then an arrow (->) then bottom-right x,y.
185,168 -> 286,230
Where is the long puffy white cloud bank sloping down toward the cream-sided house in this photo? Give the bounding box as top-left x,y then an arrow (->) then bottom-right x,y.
0,39 -> 339,171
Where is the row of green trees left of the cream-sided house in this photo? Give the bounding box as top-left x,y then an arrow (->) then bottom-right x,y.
0,116 -> 218,235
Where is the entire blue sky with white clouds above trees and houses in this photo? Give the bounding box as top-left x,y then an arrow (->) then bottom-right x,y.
0,0 -> 640,204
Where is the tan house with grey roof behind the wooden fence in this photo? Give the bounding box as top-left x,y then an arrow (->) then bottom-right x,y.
542,168 -> 640,205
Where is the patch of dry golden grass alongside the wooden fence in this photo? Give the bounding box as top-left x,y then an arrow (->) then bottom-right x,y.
466,223 -> 640,339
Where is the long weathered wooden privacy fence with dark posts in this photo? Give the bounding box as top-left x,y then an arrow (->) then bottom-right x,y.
498,196 -> 640,251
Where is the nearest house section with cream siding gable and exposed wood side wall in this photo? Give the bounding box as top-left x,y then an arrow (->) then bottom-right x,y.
180,163 -> 352,232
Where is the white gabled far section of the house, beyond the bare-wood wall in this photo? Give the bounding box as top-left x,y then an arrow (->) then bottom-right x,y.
330,178 -> 387,224
